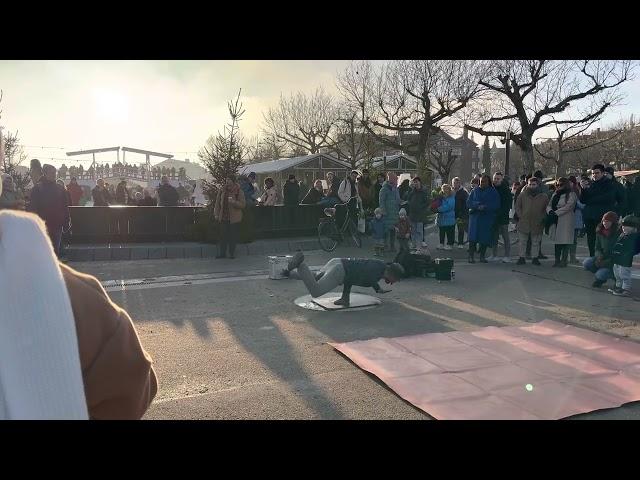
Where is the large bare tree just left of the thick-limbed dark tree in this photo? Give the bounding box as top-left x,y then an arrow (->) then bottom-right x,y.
338,60 -> 485,177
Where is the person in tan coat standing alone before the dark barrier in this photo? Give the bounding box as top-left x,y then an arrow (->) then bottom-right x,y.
213,175 -> 246,258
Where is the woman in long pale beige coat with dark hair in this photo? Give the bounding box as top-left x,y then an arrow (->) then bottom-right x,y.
547,177 -> 578,267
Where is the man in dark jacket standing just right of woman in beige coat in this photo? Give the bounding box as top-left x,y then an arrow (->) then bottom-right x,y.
580,163 -> 616,257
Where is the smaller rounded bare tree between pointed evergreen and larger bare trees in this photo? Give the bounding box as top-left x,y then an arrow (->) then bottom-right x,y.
263,87 -> 337,154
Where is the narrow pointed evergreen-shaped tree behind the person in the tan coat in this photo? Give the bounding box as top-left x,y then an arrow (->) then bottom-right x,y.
198,90 -> 248,194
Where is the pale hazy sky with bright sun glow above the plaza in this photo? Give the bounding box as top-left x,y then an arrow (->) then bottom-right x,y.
0,60 -> 640,166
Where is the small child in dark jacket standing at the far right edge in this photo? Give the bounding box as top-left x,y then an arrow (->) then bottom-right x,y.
609,215 -> 640,297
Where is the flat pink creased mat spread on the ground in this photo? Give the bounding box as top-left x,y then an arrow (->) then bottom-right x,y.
330,320 -> 640,420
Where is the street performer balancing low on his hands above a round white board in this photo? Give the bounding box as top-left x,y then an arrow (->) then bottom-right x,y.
282,252 -> 404,307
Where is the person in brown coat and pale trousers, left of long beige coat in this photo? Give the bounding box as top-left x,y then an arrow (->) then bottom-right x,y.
516,177 -> 549,265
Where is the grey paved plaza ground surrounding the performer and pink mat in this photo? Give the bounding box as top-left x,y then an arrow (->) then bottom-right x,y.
70,231 -> 640,419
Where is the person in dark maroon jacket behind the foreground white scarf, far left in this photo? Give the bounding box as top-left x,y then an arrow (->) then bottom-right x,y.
29,164 -> 70,255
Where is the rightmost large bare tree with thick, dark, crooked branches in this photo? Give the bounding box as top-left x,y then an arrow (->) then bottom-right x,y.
467,60 -> 634,173
